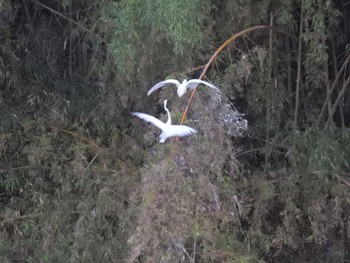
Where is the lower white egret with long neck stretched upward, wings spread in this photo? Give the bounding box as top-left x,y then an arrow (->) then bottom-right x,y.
131,100 -> 197,143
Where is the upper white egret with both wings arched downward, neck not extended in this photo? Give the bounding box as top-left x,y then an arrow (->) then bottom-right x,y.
147,79 -> 221,97
